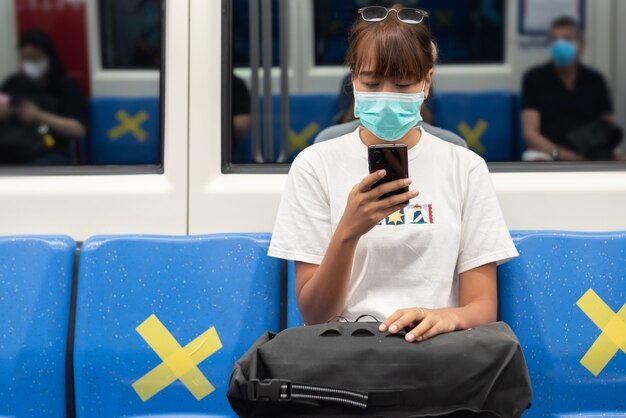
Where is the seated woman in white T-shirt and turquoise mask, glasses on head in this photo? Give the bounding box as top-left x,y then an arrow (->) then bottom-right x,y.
269,7 -> 518,342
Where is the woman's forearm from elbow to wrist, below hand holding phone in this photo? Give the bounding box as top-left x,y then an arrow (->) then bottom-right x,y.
297,228 -> 358,325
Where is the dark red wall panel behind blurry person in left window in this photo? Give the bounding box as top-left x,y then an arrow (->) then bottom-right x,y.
15,0 -> 91,96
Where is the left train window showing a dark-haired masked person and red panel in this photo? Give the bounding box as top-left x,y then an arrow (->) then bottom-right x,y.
0,0 -> 164,170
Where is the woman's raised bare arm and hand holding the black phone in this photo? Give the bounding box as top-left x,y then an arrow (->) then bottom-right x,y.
296,170 -> 418,324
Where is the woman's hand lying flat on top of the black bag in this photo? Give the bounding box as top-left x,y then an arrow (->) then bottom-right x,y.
379,308 -> 459,342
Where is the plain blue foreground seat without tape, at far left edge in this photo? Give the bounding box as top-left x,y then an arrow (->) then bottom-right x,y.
0,236 -> 76,418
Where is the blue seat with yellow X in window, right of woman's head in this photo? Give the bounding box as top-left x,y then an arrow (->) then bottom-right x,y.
433,92 -> 517,161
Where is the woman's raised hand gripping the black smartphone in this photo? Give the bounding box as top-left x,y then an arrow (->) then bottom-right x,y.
337,170 -> 419,240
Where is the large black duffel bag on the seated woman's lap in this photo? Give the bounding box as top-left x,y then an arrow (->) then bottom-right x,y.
228,322 -> 532,418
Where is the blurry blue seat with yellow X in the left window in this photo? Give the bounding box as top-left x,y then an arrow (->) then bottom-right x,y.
89,97 -> 161,164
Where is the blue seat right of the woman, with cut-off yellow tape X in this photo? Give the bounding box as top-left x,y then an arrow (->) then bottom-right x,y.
498,232 -> 626,417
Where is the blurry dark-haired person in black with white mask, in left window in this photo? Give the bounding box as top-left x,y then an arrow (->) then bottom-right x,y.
0,29 -> 89,165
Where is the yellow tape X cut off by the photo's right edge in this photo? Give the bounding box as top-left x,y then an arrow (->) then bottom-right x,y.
576,289 -> 626,376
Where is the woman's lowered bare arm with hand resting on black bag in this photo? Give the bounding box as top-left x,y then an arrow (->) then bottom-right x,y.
380,263 -> 498,342
